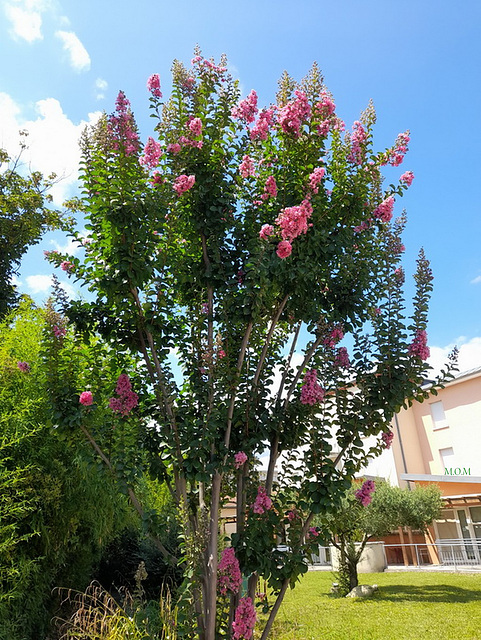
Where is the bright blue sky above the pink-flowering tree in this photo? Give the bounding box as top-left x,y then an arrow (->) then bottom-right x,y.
0,0 -> 481,368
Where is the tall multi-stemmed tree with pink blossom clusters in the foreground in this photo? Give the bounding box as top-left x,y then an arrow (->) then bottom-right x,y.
50,53 -> 454,640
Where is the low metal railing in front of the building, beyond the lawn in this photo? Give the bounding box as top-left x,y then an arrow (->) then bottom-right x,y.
312,538 -> 481,571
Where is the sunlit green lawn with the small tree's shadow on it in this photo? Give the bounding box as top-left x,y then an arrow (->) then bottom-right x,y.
256,571 -> 481,640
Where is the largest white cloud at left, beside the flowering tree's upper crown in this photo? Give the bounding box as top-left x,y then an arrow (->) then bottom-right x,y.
0,93 -> 100,205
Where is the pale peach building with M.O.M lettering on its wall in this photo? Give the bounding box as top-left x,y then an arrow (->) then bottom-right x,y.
363,367 -> 481,564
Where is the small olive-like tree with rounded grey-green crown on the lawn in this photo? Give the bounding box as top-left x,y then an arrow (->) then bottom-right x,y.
319,480 -> 442,595
